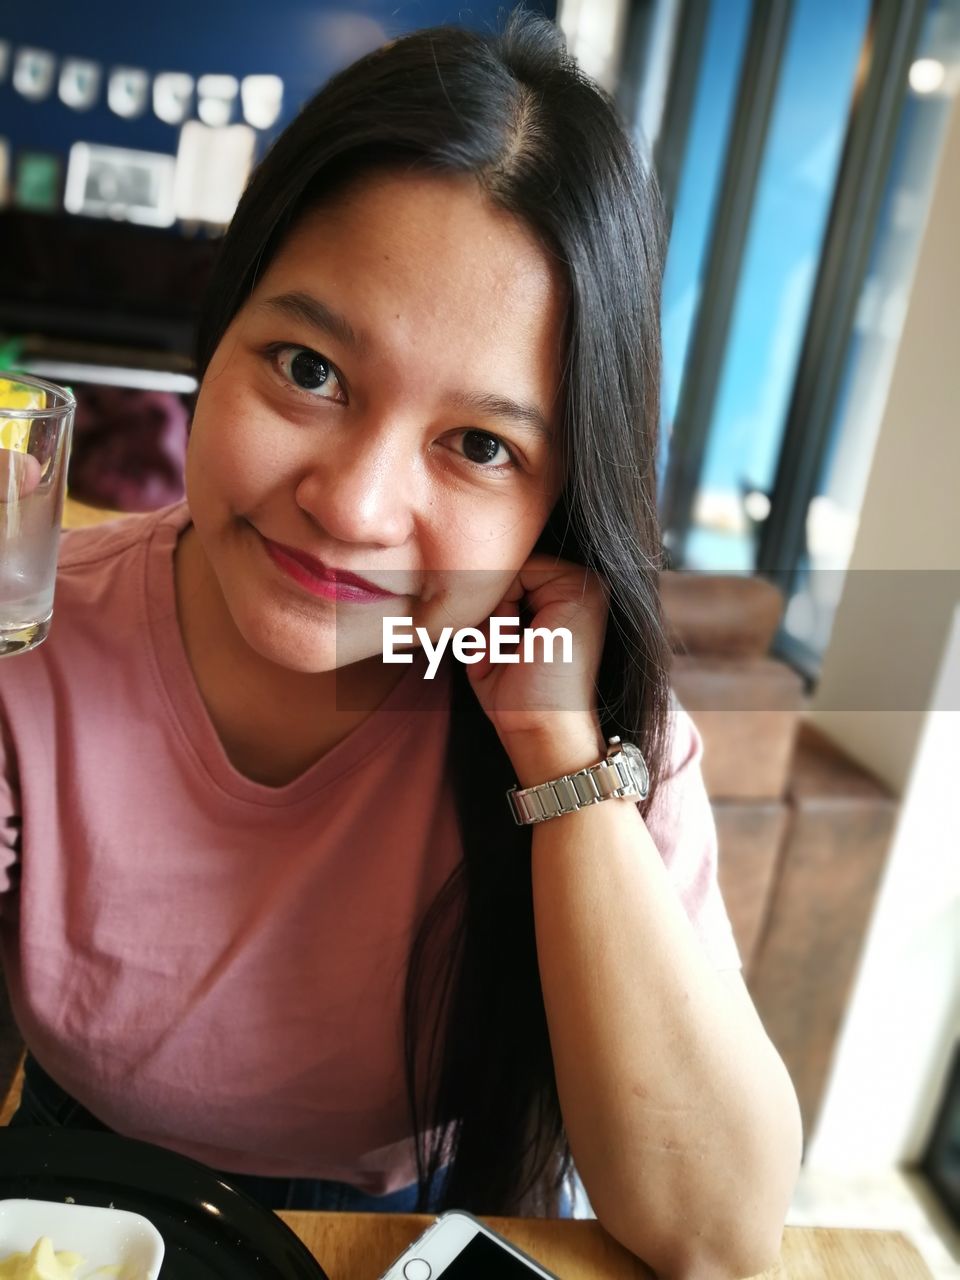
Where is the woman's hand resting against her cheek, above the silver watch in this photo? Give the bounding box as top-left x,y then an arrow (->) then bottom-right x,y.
467,553 -> 609,747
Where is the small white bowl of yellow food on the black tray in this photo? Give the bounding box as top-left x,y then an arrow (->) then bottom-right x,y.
0,1199 -> 164,1280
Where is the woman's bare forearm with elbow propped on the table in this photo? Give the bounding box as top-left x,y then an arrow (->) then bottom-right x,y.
504,718 -> 803,1280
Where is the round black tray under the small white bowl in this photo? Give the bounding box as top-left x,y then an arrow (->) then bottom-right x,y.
0,1128 -> 328,1280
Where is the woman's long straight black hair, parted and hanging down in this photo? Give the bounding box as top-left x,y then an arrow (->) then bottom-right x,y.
197,13 -> 669,1213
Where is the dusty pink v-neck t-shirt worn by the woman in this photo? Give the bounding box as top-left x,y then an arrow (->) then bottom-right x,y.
0,503 -> 740,1194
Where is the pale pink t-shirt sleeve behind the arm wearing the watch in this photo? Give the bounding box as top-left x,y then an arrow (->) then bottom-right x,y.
646,691 -> 742,969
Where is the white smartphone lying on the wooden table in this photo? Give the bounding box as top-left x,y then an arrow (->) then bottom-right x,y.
380,1210 -> 559,1280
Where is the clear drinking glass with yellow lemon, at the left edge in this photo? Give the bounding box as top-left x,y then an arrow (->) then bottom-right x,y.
0,370 -> 77,658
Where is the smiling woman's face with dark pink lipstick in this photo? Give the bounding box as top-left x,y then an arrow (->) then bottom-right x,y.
187,174 -> 566,672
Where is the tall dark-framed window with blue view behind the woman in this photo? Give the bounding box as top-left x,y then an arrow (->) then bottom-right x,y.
620,0 -> 960,678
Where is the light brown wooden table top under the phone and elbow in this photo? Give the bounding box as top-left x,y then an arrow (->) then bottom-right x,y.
273,1211 -> 932,1280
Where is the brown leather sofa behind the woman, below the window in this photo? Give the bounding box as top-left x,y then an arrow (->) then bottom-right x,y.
662,571 -> 897,1137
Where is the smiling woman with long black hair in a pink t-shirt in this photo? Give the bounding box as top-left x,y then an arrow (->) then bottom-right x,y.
0,18 -> 800,1276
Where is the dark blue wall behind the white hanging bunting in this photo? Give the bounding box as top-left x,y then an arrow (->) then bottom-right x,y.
0,0 -> 556,157
